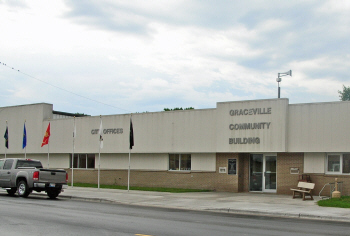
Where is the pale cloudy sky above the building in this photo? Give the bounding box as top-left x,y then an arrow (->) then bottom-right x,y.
0,0 -> 350,115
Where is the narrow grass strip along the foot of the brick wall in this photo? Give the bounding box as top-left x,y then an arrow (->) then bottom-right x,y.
68,183 -> 211,193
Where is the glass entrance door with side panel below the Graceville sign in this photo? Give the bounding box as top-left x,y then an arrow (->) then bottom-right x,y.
249,154 -> 277,192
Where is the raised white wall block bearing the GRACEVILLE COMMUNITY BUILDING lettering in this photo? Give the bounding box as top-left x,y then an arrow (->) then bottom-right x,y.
216,99 -> 288,152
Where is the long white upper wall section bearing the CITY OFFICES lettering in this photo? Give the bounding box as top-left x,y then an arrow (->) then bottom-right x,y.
39,109 -> 216,153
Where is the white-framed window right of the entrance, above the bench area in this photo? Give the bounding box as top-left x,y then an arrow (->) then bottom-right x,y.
327,154 -> 350,174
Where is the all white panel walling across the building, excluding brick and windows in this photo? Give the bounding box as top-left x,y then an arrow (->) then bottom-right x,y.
0,99 -> 350,170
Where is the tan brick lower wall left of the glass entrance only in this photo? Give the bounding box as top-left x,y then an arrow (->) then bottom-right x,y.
67,153 -> 249,192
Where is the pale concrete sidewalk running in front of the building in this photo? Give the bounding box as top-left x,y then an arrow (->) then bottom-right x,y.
50,187 -> 350,222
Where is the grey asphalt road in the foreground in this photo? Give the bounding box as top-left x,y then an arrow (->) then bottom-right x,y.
0,193 -> 350,236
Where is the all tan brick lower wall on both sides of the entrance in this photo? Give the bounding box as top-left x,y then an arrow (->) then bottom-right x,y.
67,153 -> 350,195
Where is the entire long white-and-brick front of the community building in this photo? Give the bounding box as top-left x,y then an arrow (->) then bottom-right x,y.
0,99 -> 350,195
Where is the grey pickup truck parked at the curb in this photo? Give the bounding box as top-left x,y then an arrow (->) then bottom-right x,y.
0,158 -> 68,199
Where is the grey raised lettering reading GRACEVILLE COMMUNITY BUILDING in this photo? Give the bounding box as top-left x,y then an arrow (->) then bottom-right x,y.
229,107 -> 272,144
